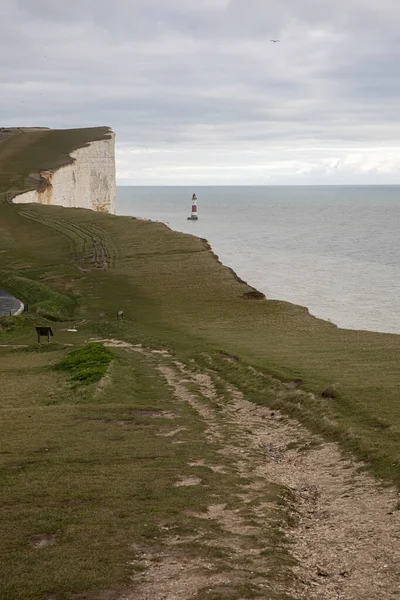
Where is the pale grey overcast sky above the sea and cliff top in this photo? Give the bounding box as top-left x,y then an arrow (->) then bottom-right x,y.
0,0 -> 400,185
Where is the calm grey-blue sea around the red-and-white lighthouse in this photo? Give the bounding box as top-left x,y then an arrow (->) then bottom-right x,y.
117,186 -> 400,333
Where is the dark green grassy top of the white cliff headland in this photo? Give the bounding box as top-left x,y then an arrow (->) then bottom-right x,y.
0,127 -> 110,202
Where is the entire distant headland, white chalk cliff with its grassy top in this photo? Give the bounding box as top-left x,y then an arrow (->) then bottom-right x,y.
0,127 -> 116,213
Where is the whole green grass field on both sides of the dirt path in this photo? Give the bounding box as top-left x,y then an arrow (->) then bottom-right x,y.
0,204 -> 400,600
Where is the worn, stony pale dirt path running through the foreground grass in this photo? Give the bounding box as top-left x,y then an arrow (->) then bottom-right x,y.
93,340 -> 400,600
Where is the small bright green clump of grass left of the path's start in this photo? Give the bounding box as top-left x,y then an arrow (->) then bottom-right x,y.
54,343 -> 113,385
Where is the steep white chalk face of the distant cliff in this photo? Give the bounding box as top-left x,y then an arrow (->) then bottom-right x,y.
13,131 -> 116,213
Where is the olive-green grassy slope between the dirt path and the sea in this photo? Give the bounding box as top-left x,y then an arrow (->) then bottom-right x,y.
0,206 -> 400,480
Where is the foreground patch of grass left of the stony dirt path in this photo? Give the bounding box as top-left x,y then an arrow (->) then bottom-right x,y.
1,355 -> 204,600
